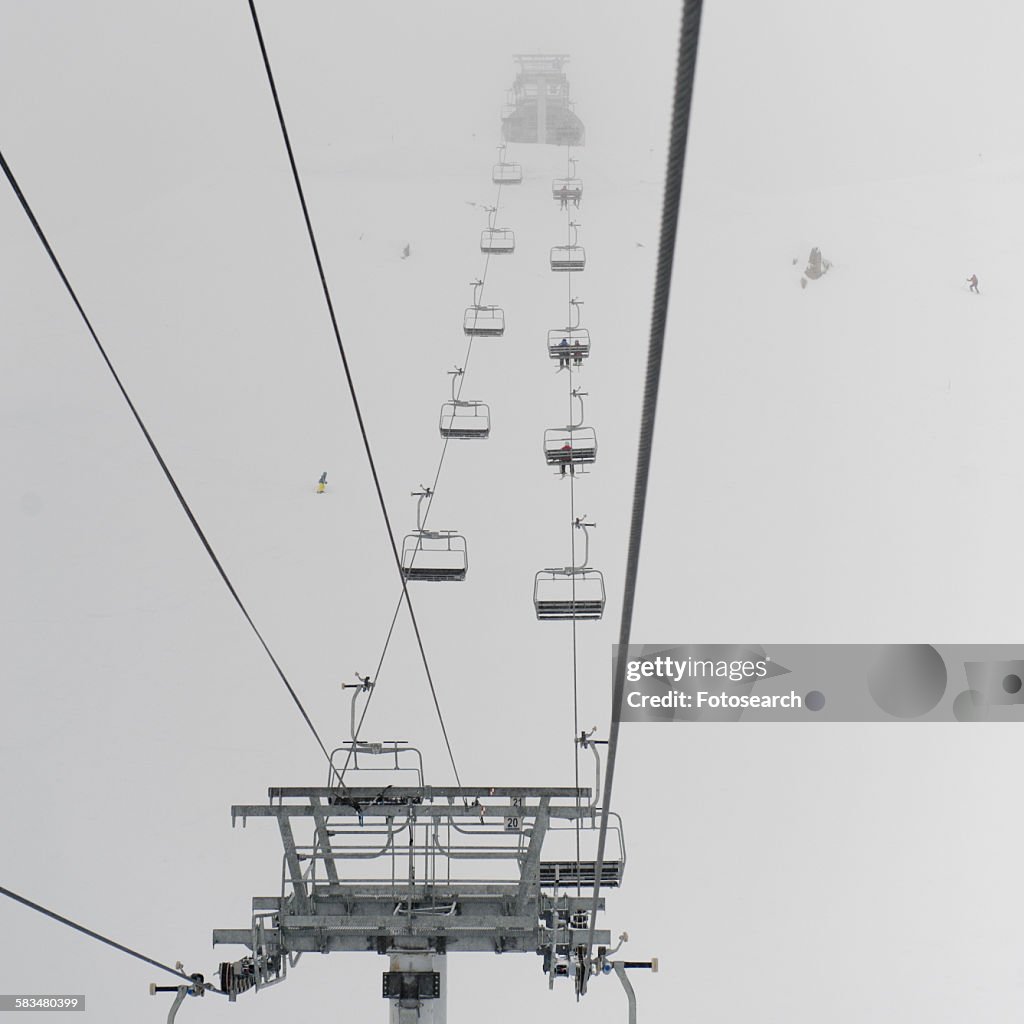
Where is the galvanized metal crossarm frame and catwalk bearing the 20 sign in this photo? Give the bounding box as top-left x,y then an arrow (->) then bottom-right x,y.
213,786 -> 625,957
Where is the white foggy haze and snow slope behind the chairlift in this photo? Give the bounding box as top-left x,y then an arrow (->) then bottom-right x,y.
0,0 -> 1024,1024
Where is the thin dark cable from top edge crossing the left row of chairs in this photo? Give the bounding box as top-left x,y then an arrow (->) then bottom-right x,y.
249,0 -> 462,786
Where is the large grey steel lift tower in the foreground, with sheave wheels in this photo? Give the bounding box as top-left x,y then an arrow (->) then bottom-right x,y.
195,736 -> 656,1024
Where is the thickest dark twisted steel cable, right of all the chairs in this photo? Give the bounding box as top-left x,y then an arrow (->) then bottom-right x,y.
583,0 -> 702,991
